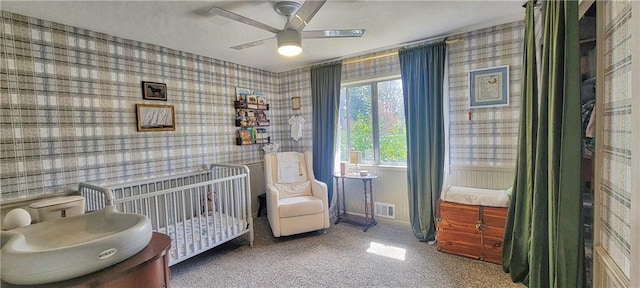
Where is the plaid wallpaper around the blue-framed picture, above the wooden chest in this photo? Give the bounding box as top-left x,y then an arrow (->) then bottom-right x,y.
447,21 -> 524,167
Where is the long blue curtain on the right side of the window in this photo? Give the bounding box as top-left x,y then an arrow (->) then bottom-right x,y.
398,42 -> 447,241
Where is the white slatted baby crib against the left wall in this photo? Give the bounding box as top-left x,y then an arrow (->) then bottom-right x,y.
78,164 -> 254,265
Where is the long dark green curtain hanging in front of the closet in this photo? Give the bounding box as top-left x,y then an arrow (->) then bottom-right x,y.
503,1 -> 585,287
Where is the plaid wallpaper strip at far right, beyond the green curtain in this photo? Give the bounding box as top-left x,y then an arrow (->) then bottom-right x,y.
596,0 -> 638,278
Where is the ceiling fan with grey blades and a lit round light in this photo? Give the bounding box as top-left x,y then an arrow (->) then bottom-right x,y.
209,0 -> 365,56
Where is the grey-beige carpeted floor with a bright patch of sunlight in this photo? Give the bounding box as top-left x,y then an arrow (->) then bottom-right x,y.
171,217 -> 523,287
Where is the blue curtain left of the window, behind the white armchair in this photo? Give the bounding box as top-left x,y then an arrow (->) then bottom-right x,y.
311,63 -> 342,203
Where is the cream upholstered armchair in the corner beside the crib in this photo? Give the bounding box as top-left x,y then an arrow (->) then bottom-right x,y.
264,151 -> 330,237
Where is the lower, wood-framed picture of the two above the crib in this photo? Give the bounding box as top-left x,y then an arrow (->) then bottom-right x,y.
136,104 -> 176,132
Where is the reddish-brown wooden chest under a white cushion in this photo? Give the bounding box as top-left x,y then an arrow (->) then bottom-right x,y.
436,201 -> 507,264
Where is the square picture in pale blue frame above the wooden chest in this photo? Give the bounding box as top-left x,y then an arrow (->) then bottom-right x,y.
469,66 -> 509,108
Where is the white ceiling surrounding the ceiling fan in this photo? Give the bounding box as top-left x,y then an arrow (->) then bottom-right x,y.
0,0 -> 524,72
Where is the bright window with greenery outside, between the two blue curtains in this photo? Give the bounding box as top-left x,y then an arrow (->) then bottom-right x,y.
338,79 -> 407,165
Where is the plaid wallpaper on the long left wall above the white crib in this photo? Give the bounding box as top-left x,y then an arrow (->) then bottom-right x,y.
0,11 -> 278,201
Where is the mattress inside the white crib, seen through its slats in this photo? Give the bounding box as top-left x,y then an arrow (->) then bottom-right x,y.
157,213 -> 247,264
